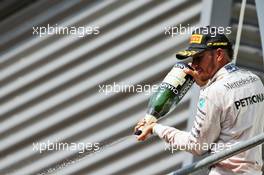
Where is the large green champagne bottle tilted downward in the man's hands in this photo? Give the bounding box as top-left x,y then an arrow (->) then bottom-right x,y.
135,62 -> 194,135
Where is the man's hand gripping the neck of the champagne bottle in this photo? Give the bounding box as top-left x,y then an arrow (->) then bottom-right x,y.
134,119 -> 156,141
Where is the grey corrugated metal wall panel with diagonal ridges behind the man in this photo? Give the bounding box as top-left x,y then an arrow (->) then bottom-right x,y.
0,0 -> 201,175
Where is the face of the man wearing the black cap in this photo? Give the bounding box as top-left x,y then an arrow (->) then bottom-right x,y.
192,50 -> 218,81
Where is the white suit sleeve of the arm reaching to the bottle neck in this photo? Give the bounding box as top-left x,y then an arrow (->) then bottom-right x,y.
153,96 -> 221,155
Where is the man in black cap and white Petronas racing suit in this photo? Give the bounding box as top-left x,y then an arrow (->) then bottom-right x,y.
135,26 -> 264,175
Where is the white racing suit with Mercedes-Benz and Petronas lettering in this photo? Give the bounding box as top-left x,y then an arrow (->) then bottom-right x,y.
153,63 -> 264,175
